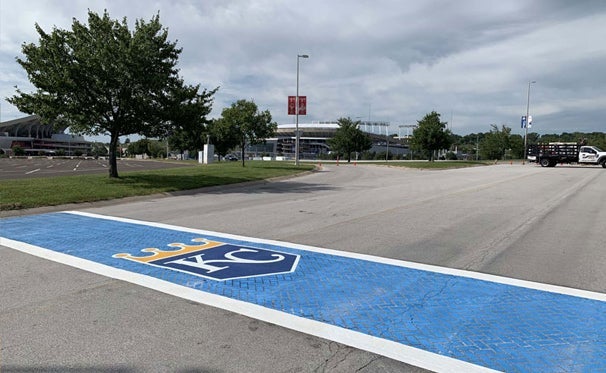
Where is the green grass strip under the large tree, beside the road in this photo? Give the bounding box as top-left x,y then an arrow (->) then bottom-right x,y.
0,161 -> 314,210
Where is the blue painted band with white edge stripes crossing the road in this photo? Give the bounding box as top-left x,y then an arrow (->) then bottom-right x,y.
0,212 -> 606,372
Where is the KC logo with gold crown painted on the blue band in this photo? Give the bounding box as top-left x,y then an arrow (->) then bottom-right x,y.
113,238 -> 299,281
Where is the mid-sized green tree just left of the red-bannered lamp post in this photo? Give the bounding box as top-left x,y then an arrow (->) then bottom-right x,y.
216,100 -> 278,167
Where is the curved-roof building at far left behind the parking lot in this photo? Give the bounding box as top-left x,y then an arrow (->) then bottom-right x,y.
0,115 -> 92,156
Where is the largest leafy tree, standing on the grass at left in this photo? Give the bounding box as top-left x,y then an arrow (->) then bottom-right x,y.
8,11 -> 214,177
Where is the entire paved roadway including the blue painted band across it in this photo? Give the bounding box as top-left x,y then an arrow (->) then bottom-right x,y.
0,164 -> 606,373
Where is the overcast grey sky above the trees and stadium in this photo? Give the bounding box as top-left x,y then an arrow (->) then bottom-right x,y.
0,0 -> 606,135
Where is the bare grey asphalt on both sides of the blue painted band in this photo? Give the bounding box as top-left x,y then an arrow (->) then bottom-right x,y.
0,164 -> 606,372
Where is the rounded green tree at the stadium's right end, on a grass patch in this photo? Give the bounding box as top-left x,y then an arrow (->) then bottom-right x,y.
411,111 -> 452,162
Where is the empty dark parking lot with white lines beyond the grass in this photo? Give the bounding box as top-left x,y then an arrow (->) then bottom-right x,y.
0,158 -> 194,180
